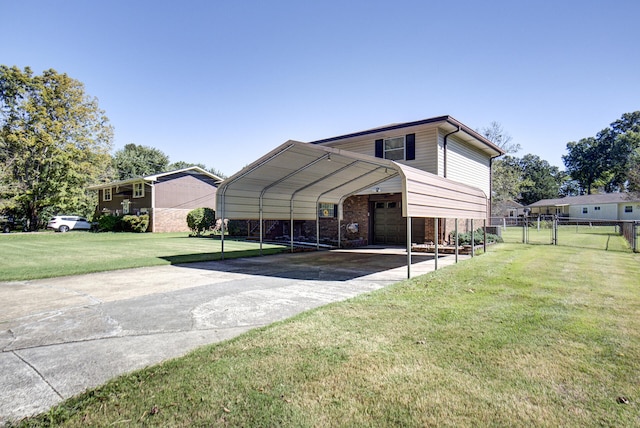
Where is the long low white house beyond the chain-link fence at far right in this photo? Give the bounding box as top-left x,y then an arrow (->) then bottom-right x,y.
528,193 -> 640,220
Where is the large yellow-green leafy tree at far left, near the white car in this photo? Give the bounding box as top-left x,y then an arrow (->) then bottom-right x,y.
0,65 -> 113,229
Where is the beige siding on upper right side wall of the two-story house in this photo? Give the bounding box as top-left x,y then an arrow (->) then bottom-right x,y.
442,135 -> 491,195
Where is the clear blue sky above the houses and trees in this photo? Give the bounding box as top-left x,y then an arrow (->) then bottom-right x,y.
5,0 -> 640,175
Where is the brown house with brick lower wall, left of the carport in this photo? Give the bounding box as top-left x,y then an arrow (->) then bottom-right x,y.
89,166 -> 222,232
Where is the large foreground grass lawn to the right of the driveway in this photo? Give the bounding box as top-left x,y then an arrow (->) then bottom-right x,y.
15,237 -> 640,427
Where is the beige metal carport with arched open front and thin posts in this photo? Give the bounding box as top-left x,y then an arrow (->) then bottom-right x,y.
216,140 -> 488,277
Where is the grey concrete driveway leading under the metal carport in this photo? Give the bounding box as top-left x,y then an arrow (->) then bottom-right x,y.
0,247 -> 464,425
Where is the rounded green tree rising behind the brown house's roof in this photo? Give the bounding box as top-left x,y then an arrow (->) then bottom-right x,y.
113,144 -> 169,180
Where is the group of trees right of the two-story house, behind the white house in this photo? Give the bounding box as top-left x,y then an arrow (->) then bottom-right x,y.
480,111 -> 640,209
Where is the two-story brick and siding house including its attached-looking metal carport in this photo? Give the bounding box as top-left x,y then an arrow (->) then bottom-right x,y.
218,116 -> 504,245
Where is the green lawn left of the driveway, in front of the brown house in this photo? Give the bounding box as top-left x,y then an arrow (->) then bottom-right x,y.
0,232 -> 284,281
